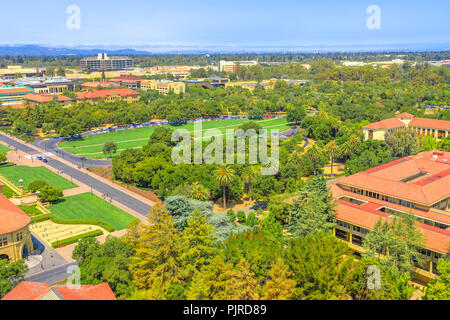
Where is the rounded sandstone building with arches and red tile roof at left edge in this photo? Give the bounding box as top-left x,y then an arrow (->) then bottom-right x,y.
0,194 -> 33,262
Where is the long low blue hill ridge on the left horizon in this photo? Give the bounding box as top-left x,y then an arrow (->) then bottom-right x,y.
0,45 -> 151,56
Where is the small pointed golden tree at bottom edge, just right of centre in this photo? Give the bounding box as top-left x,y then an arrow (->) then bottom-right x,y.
262,259 -> 296,300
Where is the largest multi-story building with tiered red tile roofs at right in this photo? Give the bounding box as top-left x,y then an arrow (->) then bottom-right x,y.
330,151 -> 450,281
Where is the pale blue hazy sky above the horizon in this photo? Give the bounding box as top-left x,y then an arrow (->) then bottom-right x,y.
0,0 -> 450,47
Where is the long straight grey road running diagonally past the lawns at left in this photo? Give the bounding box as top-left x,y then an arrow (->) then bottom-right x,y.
0,134 -> 151,215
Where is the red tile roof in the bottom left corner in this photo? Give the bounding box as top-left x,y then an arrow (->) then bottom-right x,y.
2,281 -> 117,300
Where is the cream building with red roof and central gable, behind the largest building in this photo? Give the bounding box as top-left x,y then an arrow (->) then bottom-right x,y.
363,112 -> 450,140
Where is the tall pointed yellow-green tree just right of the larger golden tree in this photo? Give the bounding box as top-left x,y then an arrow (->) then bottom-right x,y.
180,209 -> 218,282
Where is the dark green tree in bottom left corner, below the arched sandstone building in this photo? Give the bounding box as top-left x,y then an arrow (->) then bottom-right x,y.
0,258 -> 28,298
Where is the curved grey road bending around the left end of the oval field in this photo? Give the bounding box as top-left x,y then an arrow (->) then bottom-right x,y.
32,139 -> 112,168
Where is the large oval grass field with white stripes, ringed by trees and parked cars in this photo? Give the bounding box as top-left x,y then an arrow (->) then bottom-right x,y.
59,118 -> 292,159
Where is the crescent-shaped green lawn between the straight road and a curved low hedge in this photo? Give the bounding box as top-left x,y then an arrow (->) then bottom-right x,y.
47,193 -> 136,230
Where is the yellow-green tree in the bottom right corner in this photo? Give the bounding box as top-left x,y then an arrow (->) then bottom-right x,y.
423,256 -> 450,300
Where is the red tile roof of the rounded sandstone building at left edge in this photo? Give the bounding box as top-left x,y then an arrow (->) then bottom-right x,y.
0,194 -> 31,234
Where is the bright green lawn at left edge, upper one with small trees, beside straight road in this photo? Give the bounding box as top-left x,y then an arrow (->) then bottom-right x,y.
0,166 -> 78,190
